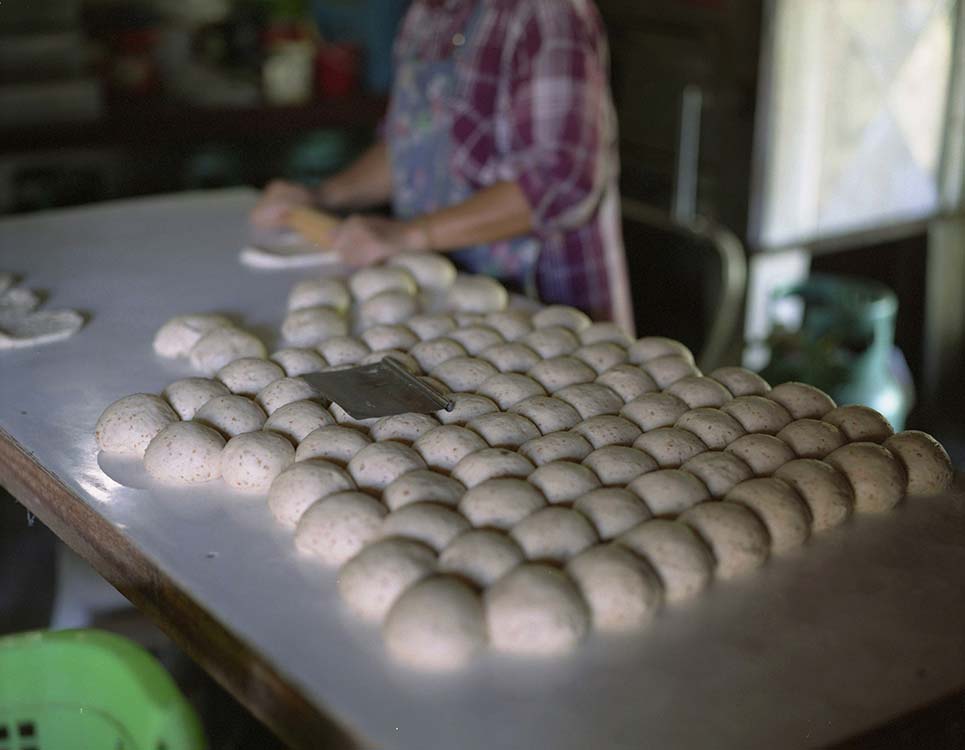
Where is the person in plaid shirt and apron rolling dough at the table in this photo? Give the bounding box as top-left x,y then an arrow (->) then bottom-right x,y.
252,0 -> 631,324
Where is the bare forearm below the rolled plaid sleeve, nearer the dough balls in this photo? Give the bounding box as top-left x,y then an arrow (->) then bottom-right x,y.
408,182 -> 533,252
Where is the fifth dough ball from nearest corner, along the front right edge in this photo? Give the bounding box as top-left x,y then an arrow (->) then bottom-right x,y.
680,500 -> 771,579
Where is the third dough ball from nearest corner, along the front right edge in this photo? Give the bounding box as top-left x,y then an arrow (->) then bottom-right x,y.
566,544 -> 663,633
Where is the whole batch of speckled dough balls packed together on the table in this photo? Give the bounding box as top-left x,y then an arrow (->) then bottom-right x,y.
96,254 -> 952,670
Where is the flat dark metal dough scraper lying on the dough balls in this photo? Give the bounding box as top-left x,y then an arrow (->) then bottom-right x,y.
301,357 -> 453,419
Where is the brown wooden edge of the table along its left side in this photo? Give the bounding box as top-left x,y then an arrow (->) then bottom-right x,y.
0,429 -> 367,749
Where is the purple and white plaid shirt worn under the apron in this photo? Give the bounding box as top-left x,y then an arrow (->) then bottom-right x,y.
395,0 -> 619,318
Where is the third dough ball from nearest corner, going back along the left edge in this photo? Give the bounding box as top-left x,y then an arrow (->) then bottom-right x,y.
295,492 -> 385,566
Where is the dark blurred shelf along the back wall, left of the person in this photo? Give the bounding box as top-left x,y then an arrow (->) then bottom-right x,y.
0,95 -> 386,153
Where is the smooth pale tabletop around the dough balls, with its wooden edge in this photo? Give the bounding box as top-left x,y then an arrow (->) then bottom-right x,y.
0,190 -> 965,750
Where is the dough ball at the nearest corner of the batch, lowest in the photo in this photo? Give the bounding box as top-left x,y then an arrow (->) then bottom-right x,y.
383,576 -> 486,672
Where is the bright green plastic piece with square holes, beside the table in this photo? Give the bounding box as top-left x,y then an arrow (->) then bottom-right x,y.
0,630 -> 206,750
